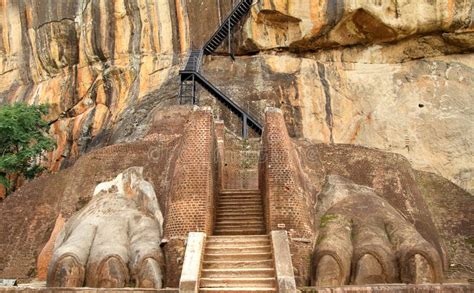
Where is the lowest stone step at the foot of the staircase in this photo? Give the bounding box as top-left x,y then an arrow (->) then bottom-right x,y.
201,278 -> 275,288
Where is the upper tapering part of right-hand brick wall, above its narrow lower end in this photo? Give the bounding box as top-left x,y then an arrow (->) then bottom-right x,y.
260,108 -> 314,239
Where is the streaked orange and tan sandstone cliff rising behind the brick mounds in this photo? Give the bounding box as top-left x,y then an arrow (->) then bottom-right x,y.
0,0 -> 474,284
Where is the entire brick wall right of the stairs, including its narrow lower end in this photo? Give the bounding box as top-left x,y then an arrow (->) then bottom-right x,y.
259,108 -> 314,285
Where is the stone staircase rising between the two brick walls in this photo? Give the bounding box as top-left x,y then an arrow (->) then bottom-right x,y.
200,190 -> 276,292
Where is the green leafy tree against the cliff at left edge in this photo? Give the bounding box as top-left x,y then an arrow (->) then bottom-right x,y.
0,103 -> 55,191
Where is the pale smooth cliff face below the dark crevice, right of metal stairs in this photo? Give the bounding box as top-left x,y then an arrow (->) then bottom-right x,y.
205,50 -> 474,192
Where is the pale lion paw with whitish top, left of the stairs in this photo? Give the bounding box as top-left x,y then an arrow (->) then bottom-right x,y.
47,167 -> 163,288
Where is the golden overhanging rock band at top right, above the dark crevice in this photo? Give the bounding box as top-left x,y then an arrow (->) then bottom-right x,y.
242,0 -> 474,51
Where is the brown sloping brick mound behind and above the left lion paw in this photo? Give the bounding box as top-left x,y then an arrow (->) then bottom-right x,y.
0,107 -> 190,281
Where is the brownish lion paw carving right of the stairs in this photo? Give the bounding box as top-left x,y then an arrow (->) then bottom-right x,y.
313,175 -> 443,286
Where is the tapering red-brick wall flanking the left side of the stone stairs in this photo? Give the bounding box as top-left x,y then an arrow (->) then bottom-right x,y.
164,109 -> 217,287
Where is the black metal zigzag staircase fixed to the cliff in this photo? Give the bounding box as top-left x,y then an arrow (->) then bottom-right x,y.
179,0 -> 263,138
